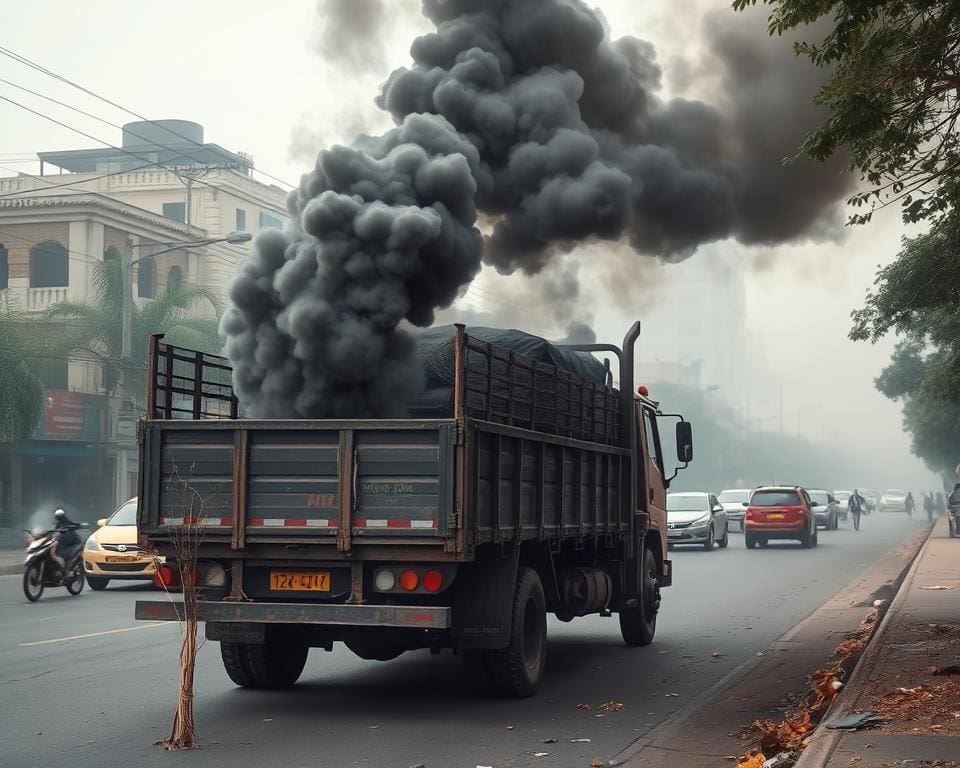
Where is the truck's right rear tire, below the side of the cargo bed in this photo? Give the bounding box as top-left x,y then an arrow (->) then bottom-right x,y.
484,568 -> 547,699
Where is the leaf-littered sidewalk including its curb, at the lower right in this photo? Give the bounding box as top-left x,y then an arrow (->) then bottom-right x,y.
796,517 -> 960,768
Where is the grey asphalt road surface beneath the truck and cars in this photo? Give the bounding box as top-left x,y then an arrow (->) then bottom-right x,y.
0,514 -> 921,768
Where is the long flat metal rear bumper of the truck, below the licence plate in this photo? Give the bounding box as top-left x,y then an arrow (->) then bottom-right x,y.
135,600 -> 451,629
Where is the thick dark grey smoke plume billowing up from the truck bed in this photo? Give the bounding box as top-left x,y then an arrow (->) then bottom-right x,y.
222,0 -> 848,417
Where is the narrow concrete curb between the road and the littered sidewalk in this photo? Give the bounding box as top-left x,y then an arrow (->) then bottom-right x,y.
794,522 -> 937,768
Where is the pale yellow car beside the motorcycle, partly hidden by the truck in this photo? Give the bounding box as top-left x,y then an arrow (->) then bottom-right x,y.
83,499 -> 156,590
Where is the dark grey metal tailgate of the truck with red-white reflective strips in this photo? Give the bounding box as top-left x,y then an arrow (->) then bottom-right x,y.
140,420 -> 455,553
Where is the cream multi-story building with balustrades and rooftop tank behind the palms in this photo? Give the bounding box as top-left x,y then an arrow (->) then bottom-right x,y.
0,121 -> 286,527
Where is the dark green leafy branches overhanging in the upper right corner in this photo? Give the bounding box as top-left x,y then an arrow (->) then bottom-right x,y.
733,0 -> 960,222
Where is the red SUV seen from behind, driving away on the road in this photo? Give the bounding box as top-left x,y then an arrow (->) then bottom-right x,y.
743,486 -> 817,549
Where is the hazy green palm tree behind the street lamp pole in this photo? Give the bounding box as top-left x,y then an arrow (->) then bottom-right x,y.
46,258 -> 222,400
